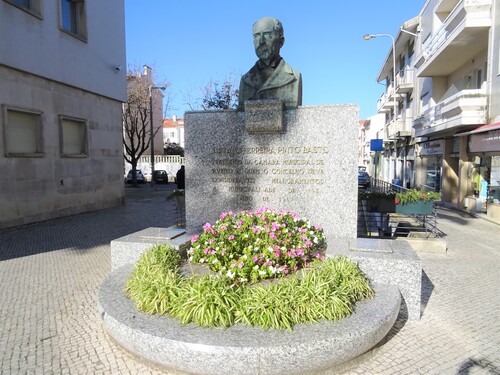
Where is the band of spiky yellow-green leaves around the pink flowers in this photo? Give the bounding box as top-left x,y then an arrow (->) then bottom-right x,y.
126,246 -> 374,330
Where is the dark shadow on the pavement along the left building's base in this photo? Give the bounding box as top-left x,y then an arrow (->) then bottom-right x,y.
0,184 -> 176,261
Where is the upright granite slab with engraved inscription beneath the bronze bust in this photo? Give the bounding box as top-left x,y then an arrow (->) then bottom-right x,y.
185,105 -> 358,238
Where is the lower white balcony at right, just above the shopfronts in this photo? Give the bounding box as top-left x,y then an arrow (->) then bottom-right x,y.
413,90 -> 488,137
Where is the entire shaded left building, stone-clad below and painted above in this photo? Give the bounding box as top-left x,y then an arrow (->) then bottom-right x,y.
0,0 -> 126,228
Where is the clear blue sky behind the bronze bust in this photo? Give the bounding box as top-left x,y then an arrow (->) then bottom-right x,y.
125,0 -> 425,119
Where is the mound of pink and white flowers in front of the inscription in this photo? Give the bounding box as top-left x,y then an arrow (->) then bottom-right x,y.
188,208 -> 324,283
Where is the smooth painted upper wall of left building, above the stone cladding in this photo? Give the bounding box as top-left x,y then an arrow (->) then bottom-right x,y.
0,0 -> 127,101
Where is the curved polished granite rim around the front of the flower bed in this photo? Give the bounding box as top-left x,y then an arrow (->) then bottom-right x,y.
99,264 -> 401,375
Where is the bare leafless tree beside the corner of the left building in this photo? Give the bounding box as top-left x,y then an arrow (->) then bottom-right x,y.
122,66 -> 168,186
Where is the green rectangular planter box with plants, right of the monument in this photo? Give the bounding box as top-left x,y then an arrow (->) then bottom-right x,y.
394,189 -> 441,215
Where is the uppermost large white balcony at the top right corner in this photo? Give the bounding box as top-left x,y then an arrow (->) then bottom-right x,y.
415,0 -> 493,77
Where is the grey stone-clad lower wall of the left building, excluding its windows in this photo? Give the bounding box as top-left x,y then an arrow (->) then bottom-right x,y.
0,66 -> 124,228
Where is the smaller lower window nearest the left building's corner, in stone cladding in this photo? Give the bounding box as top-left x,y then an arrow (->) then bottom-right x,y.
59,116 -> 87,157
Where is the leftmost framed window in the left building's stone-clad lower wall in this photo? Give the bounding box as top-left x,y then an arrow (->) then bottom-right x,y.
4,108 -> 43,157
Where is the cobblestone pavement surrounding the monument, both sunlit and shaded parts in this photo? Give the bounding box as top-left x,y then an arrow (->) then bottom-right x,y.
0,185 -> 500,375
